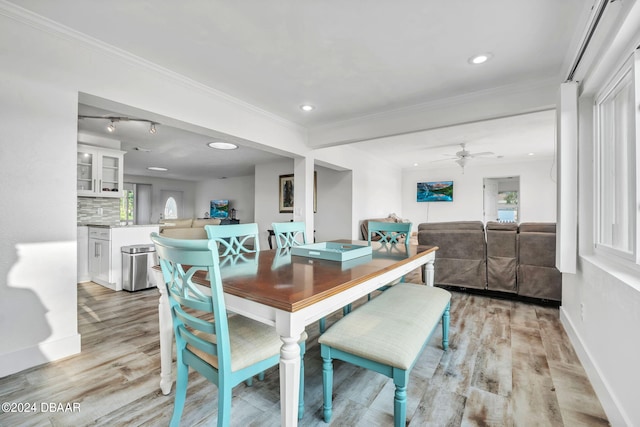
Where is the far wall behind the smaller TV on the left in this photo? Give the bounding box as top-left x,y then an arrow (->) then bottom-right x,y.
194,175 -> 255,223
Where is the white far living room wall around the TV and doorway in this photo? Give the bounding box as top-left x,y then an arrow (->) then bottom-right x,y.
402,159 -> 556,231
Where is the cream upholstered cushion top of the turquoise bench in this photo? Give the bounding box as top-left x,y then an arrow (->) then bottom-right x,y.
318,283 -> 451,370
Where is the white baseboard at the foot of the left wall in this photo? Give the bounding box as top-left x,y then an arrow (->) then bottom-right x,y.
0,334 -> 80,378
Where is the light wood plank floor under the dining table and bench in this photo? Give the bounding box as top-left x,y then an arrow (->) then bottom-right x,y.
0,276 -> 608,427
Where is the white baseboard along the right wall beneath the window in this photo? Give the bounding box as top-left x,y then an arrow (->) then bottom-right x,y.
560,306 -> 632,427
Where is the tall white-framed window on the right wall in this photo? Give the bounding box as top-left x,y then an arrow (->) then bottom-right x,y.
594,53 -> 640,259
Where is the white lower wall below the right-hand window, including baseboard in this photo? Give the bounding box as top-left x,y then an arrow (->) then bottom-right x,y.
560,256 -> 640,426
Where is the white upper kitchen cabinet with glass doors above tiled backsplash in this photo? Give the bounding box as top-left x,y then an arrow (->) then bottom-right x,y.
77,144 -> 124,197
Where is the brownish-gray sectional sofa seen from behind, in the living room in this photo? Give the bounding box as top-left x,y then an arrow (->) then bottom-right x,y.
418,221 -> 562,301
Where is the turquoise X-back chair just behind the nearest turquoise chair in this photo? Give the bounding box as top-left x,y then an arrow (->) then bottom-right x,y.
204,222 -> 260,257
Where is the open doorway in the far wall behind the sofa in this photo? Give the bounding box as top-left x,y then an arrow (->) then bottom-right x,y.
483,176 -> 520,224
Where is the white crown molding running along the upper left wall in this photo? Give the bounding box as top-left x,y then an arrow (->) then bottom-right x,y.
0,0 -> 306,133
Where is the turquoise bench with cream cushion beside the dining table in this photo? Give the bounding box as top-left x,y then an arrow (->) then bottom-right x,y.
318,283 -> 451,427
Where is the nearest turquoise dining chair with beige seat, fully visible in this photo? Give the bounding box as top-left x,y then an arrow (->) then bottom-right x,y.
151,233 -> 307,427
